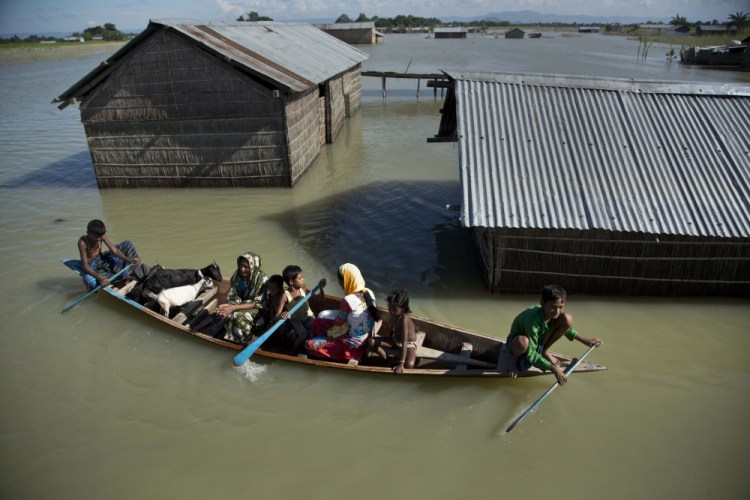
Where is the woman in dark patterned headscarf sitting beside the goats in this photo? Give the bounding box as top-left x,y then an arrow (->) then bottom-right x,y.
217,252 -> 268,344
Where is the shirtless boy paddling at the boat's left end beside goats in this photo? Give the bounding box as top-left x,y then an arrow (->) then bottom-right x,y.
78,219 -> 140,290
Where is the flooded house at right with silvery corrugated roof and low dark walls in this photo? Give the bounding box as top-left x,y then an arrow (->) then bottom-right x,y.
429,72 -> 750,296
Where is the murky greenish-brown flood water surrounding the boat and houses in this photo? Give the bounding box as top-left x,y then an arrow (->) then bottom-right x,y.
0,34 -> 750,500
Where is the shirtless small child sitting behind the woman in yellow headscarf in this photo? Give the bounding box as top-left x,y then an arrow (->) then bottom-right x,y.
369,290 -> 417,374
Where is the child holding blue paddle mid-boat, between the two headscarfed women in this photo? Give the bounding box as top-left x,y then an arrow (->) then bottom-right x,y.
274,264 -> 326,353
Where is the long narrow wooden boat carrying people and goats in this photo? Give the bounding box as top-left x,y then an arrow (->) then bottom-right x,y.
63,260 -> 606,377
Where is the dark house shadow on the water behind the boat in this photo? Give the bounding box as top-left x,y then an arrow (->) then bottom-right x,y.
268,181 -> 483,298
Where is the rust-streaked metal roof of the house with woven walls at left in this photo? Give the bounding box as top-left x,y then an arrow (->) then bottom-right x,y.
55,19 -> 369,102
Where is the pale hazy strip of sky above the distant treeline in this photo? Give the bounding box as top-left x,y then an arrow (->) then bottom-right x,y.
0,0 -> 750,36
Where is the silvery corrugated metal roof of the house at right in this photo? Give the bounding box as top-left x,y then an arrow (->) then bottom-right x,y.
448,73 -> 750,237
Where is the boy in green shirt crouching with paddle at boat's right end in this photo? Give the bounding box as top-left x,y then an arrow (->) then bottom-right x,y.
501,285 -> 602,385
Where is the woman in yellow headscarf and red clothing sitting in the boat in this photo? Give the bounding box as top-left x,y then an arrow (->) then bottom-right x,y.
305,263 -> 380,361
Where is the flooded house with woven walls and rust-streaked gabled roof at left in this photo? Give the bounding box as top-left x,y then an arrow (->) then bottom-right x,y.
54,20 -> 368,187
